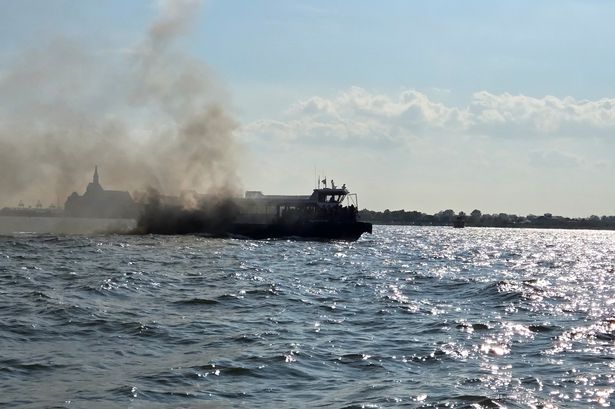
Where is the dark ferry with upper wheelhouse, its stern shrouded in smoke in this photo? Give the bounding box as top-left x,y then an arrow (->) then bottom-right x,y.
137,183 -> 372,241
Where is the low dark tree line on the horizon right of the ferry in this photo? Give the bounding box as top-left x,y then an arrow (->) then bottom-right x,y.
359,209 -> 615,230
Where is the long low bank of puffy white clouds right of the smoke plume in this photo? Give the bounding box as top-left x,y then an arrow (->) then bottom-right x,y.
243,87 -> 615,144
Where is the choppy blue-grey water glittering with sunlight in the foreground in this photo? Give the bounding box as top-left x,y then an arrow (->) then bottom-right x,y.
0,227 -> 615,408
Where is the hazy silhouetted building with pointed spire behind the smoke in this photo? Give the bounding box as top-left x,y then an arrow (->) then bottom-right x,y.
64,166 -> 138,219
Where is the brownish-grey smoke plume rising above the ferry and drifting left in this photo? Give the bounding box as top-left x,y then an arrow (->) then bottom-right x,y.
0,0 -> 239,207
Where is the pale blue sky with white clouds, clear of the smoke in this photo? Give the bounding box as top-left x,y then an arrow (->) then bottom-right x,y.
0,0 -> 615,217
